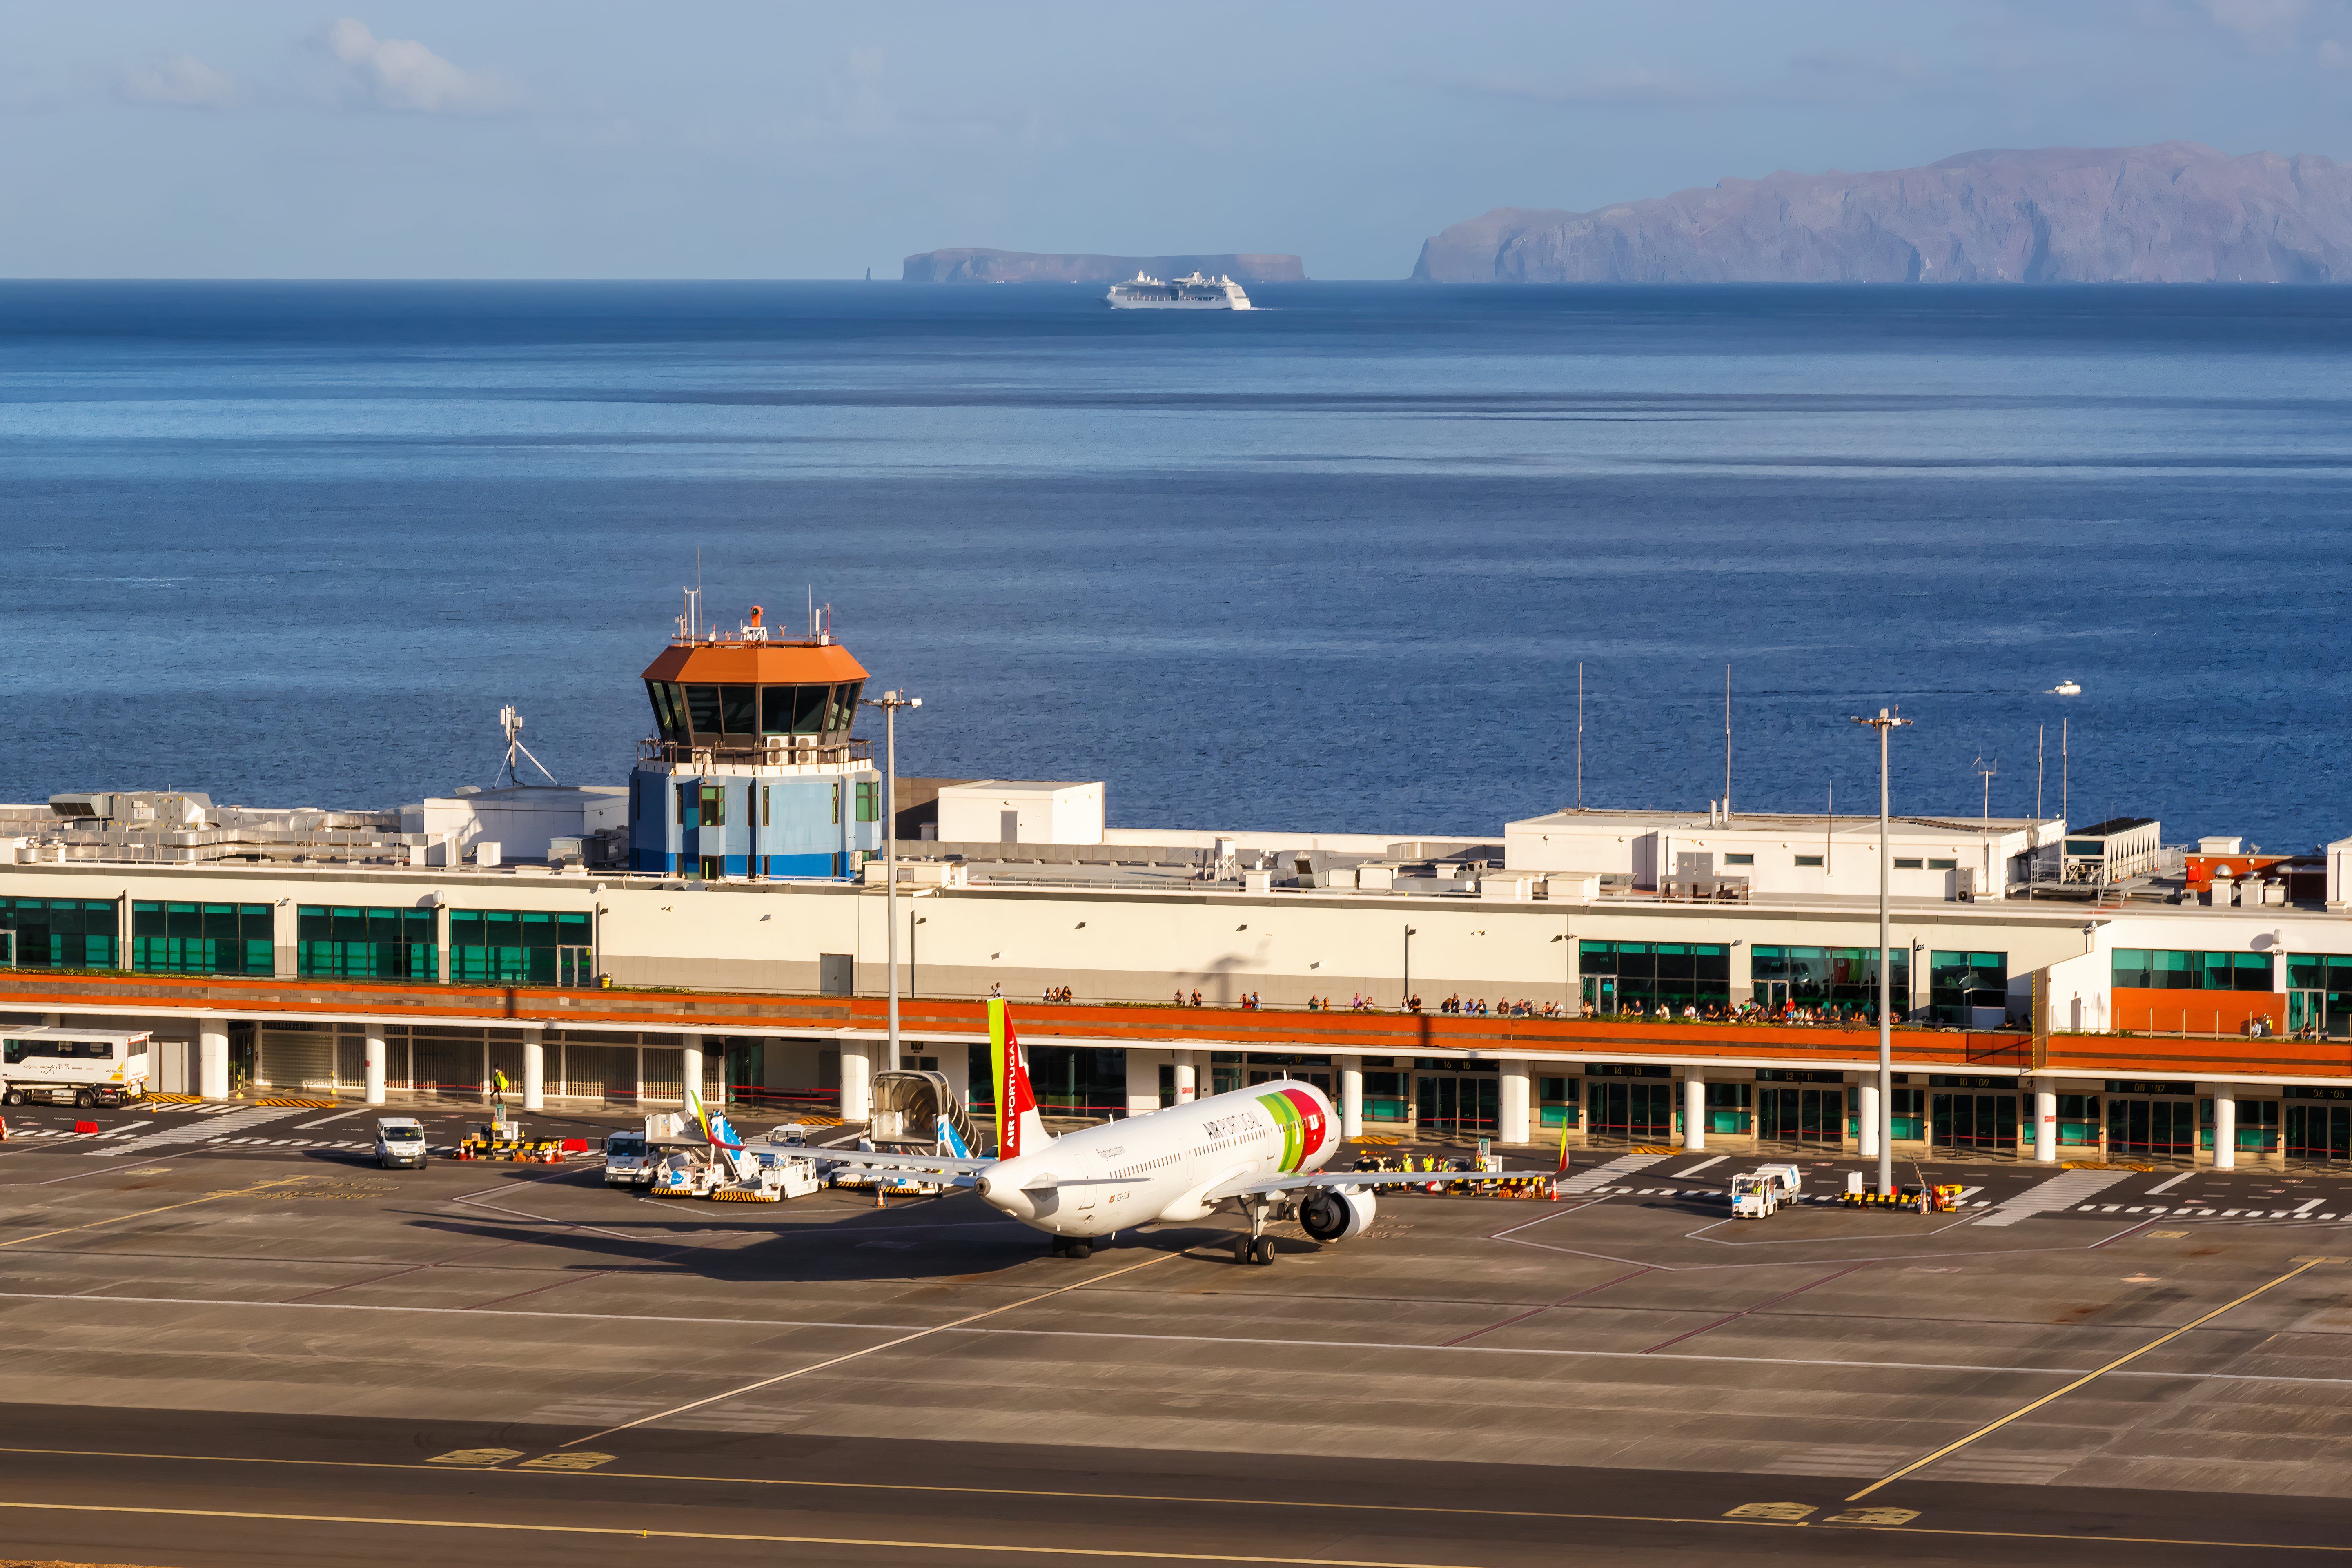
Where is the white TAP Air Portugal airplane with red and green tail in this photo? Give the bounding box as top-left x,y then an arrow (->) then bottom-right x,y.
800,999 -> 1566,1265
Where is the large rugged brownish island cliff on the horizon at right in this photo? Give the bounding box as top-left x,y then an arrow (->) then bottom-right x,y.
1414,141 -> 2352,282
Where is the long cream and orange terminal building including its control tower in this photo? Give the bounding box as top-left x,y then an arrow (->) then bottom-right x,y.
0,621 -> 2352,1166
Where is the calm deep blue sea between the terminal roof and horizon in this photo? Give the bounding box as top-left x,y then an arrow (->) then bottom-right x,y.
0,282 -> 2352,849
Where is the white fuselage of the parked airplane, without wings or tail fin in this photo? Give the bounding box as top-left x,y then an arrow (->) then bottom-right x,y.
974,1079 -> 1341,1236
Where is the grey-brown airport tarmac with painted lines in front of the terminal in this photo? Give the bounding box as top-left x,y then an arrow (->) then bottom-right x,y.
0,1107 -> 2352,1568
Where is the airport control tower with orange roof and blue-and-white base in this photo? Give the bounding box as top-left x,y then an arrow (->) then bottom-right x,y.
628,597 -> 882,879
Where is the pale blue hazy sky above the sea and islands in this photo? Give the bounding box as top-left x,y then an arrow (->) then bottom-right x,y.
0,0 -> 2352,277
